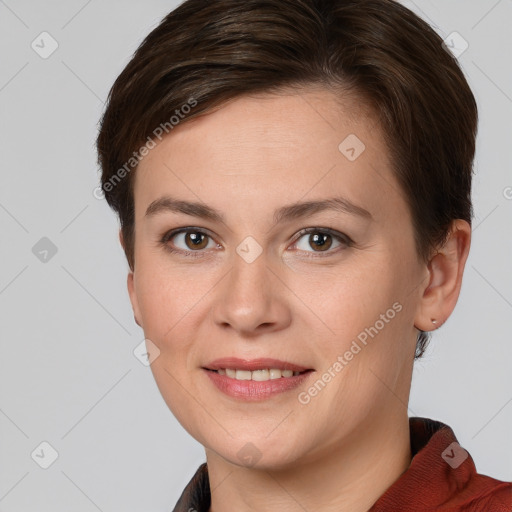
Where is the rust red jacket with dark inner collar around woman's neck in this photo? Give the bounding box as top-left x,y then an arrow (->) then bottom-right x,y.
173,418 -> 512,512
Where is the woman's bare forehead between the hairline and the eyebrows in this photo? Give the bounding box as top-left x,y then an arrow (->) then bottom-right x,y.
134,89 -> 406,226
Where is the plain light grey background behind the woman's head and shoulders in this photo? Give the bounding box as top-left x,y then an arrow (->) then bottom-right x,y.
0,0 -> 512,512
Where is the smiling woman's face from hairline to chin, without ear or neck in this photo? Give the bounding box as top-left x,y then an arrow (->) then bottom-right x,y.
128,89 -> 428,467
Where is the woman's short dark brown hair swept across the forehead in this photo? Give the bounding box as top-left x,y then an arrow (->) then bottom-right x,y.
97,0 -> 478,357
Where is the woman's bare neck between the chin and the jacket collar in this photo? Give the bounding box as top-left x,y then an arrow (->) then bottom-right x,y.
206,413 -> 411,512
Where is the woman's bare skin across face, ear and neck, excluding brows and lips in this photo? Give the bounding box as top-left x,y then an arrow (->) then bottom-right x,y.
121,89 -> 471,512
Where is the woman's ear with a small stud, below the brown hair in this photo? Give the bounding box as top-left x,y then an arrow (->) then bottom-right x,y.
414,219 -> 471,331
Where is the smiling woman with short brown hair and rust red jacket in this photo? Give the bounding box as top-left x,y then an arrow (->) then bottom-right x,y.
97,0 -> 512,512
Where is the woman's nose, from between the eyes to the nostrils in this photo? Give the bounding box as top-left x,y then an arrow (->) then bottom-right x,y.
213,251 -> 292,337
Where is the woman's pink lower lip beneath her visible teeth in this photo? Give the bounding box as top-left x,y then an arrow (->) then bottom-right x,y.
203,368 -> 313,401
